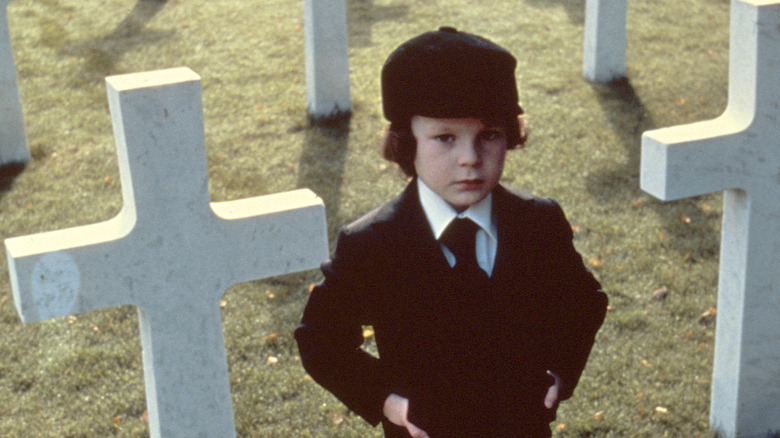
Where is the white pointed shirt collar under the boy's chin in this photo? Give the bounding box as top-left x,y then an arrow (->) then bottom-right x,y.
417,178 -> 498,241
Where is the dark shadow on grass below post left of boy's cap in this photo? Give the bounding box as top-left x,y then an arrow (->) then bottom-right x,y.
297,114 -> 351,242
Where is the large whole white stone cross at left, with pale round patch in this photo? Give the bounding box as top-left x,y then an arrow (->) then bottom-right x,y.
6,68 -> 328,438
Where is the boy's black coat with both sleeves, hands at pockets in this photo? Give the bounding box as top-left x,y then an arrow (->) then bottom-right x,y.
295,181 -> 607,438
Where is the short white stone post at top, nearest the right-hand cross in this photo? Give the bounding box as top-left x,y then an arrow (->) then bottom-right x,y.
582,0 -> 628,83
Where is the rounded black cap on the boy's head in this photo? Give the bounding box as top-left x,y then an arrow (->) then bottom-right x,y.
382,27 -> 523,122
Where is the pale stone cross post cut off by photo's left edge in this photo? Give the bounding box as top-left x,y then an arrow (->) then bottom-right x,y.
0,0 -> 30,166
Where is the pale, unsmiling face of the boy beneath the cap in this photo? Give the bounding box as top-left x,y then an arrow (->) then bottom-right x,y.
412,116 -> 507,211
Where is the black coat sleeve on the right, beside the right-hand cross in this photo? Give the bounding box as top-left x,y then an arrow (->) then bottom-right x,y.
545,203 -> 608,400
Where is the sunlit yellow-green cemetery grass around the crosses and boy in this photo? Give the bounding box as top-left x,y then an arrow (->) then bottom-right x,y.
0,0 -> 729,437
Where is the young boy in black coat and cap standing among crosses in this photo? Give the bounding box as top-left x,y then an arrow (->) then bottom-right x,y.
295,28 -> 607,438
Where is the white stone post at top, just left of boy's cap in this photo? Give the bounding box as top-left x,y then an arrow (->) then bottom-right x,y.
303,0 -> 352,122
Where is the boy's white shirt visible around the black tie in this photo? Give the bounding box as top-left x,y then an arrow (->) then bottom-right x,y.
417,178 -> 498,276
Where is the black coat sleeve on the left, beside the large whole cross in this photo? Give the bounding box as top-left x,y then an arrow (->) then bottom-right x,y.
295,231 -> 391,426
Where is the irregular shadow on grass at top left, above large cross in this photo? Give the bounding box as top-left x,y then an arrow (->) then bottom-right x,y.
60,0 -> 175,86
